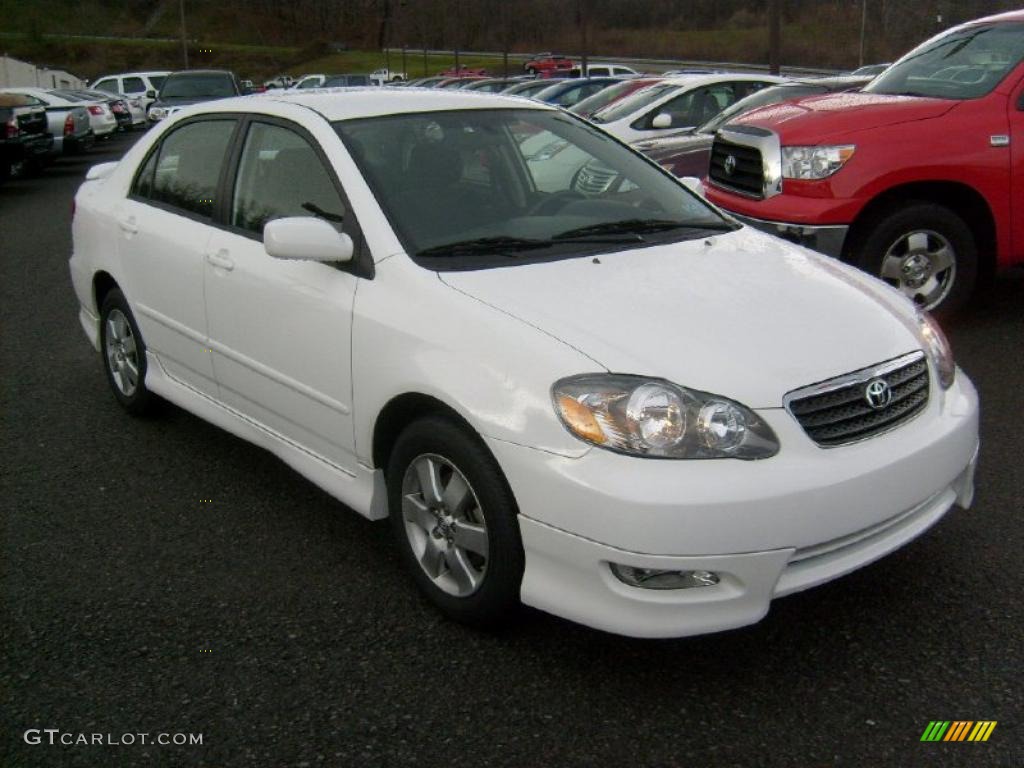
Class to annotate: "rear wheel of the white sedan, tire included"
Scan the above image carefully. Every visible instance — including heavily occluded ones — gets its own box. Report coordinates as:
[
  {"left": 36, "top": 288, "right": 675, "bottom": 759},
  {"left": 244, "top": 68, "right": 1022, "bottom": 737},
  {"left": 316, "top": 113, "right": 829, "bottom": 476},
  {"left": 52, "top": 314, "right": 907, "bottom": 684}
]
[{"left": 99, "top": 288, "right": 156, "bottom": 416}]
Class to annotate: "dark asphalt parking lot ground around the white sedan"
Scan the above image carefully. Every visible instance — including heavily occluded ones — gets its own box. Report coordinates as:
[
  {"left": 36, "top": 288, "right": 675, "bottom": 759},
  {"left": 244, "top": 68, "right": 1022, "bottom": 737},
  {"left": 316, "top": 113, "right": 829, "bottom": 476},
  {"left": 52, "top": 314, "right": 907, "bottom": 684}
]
[{"left": 0, "top": 129, "right": 1024, "bottom": 768}]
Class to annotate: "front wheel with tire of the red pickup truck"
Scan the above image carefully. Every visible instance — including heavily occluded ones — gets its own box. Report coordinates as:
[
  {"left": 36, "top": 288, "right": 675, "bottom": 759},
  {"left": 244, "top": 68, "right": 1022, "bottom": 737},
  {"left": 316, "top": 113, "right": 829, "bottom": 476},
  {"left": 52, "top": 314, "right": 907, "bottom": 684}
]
[{"left": 851, "top": 201, "right": 978, "bottom": 316}]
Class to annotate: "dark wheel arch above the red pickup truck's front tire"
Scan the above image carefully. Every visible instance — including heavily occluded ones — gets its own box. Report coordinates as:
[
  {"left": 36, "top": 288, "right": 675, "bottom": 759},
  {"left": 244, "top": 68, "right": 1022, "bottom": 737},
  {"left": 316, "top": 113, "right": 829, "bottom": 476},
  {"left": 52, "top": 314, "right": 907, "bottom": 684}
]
[{"left": 842, "top": 180, "right": 998, "bottom": 280}]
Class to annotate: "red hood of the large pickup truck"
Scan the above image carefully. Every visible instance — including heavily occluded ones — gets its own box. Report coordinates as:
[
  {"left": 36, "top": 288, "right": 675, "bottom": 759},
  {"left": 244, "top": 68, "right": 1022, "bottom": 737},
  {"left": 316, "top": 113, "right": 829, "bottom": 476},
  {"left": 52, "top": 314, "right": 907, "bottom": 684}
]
[{"left": 731, "top": 92, "right": 957, "bottom": 145}]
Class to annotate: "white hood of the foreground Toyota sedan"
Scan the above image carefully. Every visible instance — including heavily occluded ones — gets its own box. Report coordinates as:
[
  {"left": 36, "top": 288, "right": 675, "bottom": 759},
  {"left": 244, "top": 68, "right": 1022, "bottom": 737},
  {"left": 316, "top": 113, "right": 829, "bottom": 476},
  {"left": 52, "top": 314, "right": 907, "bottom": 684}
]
[{"left": 439, "top": 227, "right": 921, "bottom": 408}]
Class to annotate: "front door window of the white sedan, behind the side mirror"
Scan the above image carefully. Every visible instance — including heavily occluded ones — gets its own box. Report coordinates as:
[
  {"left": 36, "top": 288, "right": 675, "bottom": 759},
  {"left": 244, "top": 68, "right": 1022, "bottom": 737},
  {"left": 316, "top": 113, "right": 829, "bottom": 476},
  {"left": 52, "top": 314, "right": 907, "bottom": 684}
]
[{"left": 231, "top": 123, "right": 345, "bottom": 234}]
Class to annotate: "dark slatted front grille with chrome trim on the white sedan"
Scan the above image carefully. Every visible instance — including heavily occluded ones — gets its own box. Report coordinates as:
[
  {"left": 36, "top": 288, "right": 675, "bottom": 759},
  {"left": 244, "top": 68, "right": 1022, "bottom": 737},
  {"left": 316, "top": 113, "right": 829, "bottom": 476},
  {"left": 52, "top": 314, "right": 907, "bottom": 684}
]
[{"left": 785, "top": 352, "right": 929, "bottom": 447}]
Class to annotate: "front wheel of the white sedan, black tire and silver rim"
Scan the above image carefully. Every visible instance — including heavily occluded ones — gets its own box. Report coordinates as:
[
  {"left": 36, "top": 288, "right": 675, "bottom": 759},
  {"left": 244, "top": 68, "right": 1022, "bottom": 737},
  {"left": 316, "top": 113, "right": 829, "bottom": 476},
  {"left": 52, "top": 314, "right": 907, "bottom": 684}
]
[{"left": 387, "top": 416, "right": 523, "bottom": 627}]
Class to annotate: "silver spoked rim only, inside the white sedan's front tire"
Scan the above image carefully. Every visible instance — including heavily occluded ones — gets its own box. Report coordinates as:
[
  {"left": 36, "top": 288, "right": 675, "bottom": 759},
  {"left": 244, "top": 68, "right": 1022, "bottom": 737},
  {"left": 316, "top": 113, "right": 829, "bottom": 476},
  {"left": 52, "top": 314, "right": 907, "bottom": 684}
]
[{"left": 401, "top": 454, "right": 487, "bottom": 597}]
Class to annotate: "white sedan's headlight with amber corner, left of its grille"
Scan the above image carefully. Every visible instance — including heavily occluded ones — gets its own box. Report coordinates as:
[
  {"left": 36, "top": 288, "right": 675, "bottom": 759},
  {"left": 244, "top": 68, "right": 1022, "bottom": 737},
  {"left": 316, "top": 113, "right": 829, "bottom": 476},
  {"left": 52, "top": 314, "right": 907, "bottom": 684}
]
[{"left": 551, "top": 374, "right": 778, "bottom": 459}]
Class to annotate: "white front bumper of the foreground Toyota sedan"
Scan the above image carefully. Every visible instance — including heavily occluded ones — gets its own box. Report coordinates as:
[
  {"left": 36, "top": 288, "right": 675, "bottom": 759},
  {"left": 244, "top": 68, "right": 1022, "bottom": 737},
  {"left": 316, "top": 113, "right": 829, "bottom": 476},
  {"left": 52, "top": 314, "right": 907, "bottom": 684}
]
[{"left": 488, "top": 374, "right": 978, "bottom": 637}]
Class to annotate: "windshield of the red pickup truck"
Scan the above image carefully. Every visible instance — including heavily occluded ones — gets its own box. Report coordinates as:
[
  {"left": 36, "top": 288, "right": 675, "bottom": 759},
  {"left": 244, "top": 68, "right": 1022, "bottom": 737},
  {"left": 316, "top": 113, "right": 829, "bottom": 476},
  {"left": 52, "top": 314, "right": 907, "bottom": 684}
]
[{"left": 864, "top": 22, "right": 1024, "bottom": 99}]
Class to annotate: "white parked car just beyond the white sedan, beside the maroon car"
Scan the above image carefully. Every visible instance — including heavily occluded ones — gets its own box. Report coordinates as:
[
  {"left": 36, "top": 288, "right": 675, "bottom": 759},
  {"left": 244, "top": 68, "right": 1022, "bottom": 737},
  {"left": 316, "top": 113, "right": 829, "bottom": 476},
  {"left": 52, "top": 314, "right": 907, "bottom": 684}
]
[{"left": 590, "top": 74, "right": 785, "bottom": 143}]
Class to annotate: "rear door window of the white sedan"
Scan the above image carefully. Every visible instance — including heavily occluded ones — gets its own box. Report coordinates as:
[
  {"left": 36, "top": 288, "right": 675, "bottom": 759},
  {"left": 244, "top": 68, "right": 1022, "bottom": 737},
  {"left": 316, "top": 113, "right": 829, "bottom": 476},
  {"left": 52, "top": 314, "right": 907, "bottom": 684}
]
[{"left": 150, "top": 120, "right": 236, "bottom": 218}]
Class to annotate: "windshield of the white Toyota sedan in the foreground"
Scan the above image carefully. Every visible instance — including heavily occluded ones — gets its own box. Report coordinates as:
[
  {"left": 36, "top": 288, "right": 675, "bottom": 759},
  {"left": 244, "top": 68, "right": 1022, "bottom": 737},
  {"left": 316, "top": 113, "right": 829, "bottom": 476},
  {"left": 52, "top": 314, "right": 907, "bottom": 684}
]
[{"left": 335, "top": 109, "right": 734, "bottom": 269}]
